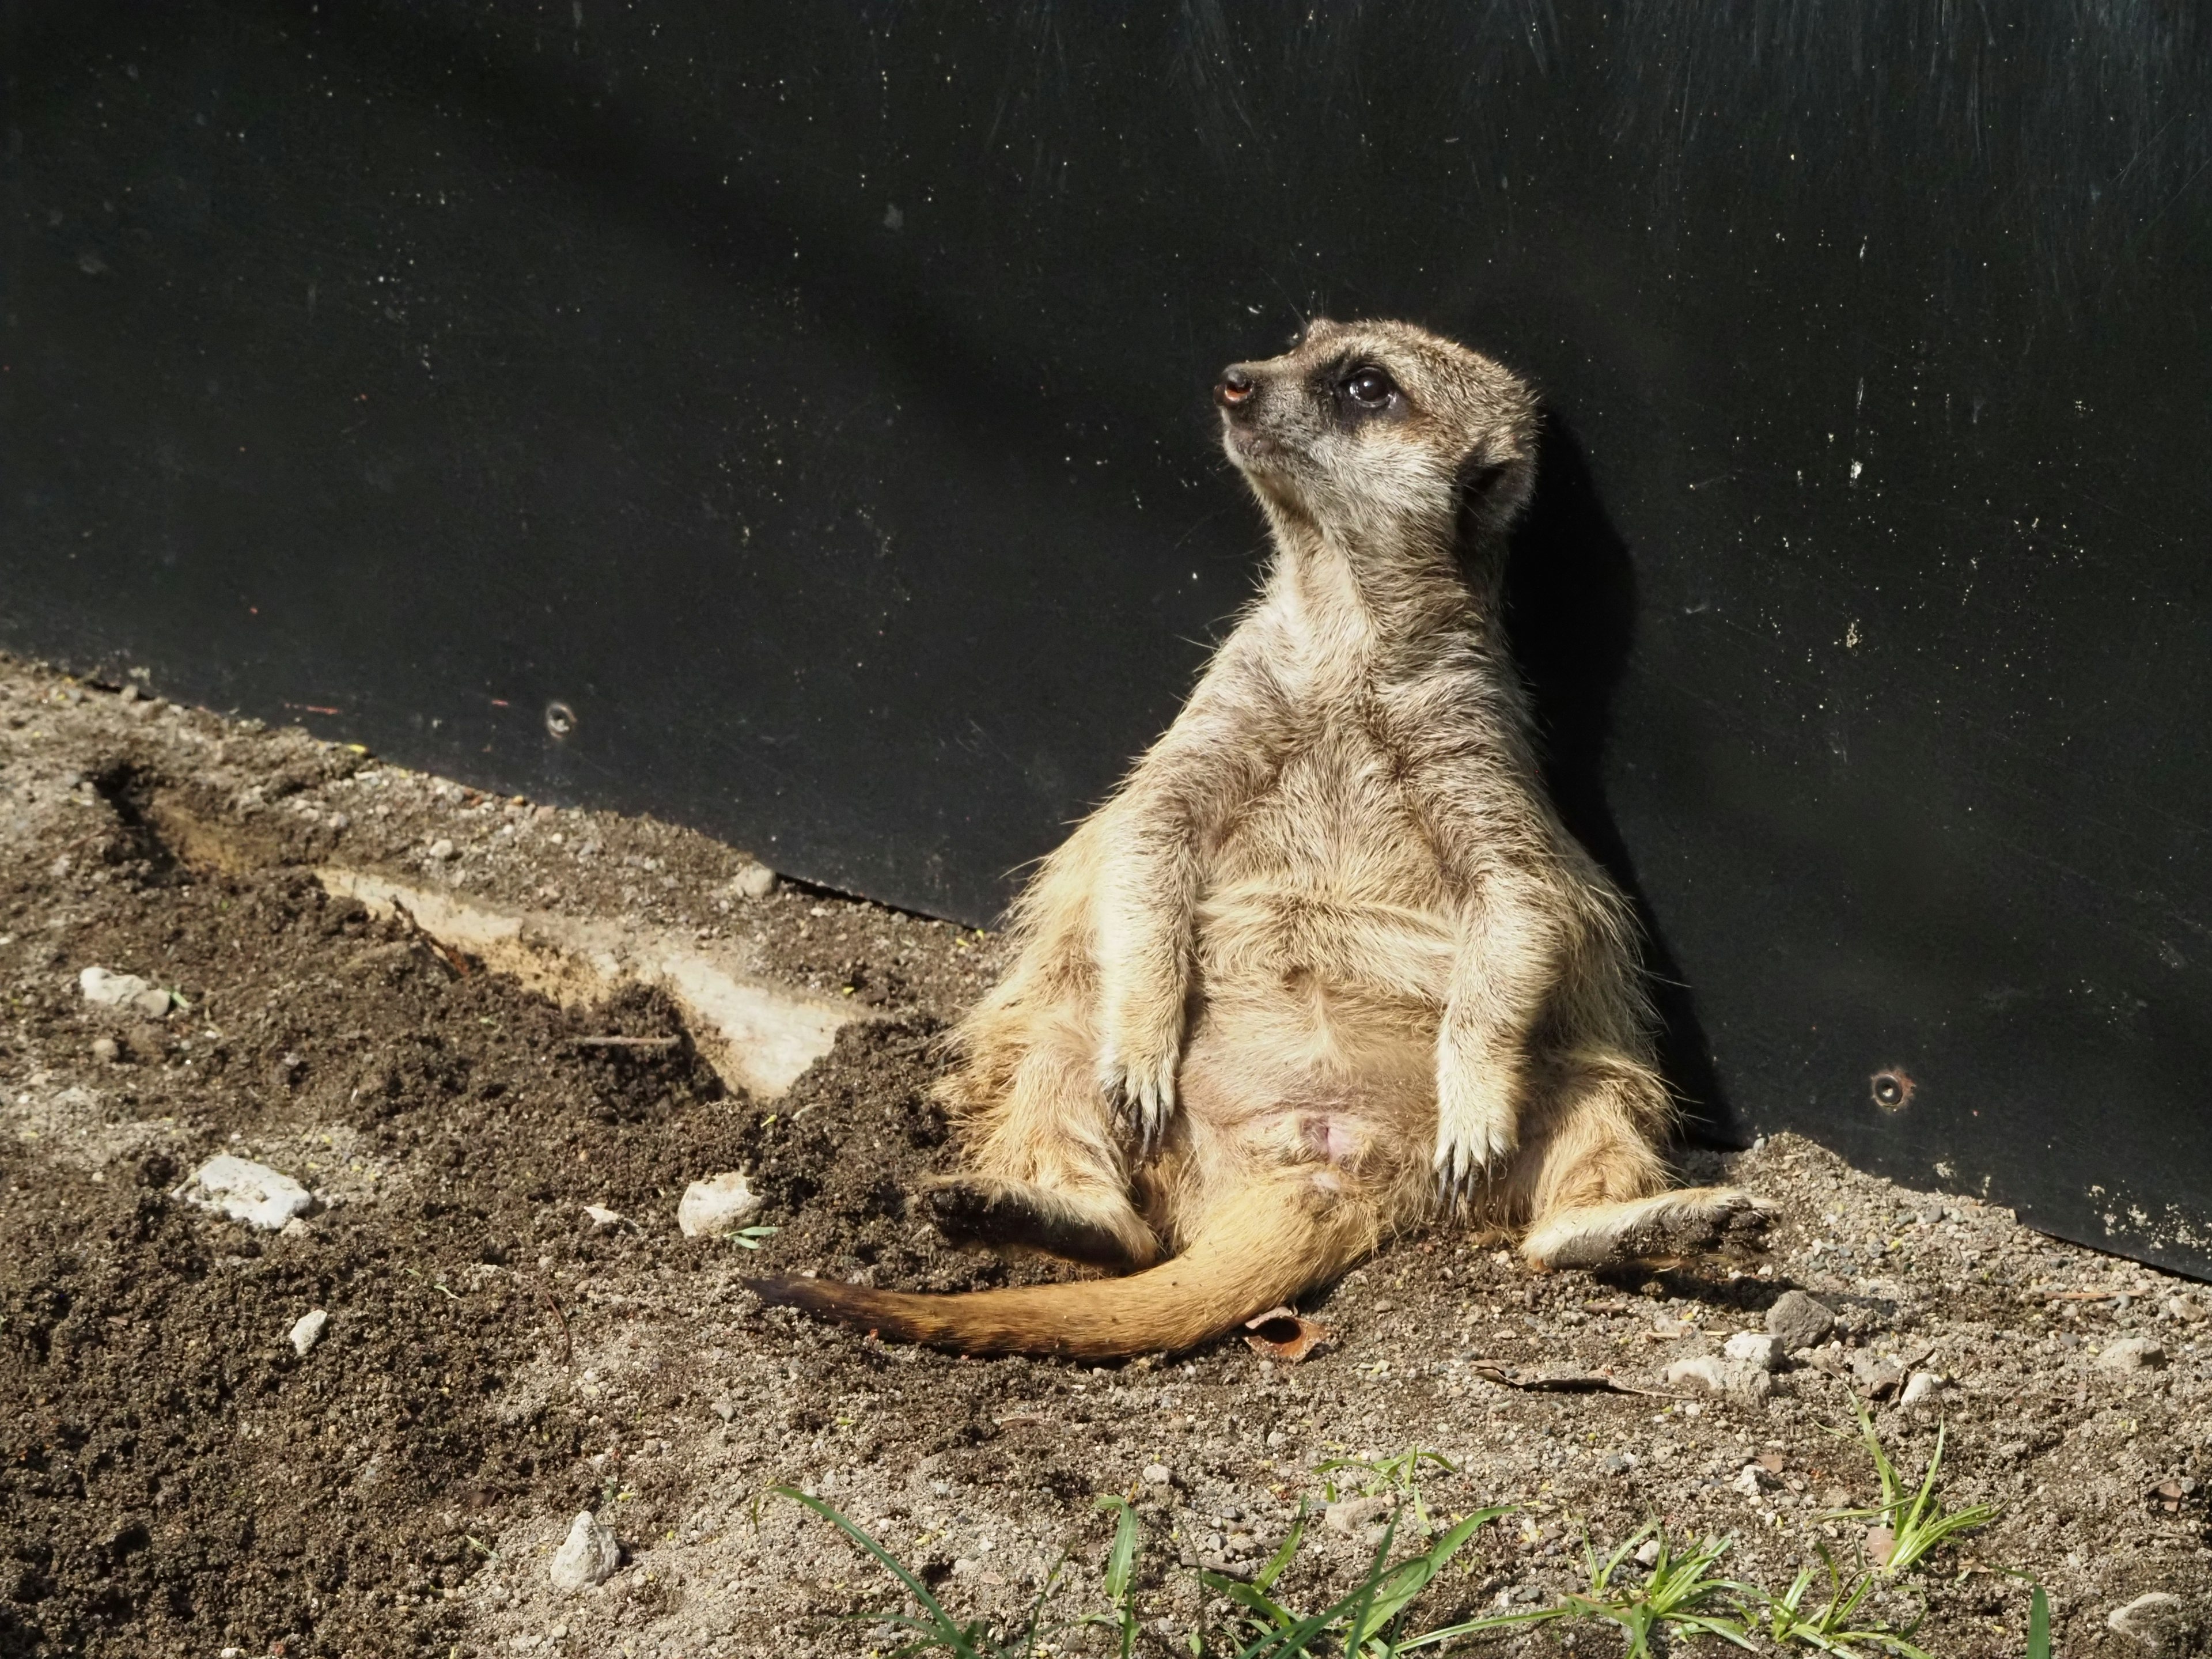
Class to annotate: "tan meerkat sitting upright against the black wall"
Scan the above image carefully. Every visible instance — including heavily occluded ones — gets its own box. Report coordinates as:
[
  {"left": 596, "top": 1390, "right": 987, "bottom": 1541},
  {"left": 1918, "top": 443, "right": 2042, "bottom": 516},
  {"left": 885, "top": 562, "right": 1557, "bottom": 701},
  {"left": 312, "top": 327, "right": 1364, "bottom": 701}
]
[{"left": 754, "top": 321, "right": 1765, "bottom": 1358}]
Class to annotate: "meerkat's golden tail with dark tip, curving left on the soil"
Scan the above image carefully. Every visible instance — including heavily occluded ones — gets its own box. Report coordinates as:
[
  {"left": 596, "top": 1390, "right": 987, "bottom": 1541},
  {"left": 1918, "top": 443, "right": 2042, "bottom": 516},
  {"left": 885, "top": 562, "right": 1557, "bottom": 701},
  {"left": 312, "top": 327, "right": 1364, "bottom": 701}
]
[{"left": 745, "top": 1181, "right": 1376, "bottom": 1361}]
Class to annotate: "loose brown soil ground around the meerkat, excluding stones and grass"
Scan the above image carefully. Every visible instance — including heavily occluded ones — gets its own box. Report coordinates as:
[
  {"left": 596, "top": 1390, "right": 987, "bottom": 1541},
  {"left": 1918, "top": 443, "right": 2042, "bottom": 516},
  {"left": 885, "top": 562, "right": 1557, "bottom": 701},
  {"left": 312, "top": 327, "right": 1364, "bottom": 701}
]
[{"left": 0, "top": 659, "right": 2212, "bottom": 1659}]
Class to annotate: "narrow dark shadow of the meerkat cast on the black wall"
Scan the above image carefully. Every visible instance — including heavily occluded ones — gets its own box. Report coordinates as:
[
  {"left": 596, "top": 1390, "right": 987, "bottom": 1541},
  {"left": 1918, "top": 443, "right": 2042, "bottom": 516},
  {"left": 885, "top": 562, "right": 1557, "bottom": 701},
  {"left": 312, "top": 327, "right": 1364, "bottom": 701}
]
[{"left": 1506, "top": 411, "right": 1748, "bottom": 1146}]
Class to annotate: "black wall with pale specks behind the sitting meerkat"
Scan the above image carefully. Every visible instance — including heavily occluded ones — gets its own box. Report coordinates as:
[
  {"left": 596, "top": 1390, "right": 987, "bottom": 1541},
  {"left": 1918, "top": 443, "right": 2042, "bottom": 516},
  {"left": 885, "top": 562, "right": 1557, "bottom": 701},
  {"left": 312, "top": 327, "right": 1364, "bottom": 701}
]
[{"left": 0, "top": 0, "right": 2212, "bottom": 1270}]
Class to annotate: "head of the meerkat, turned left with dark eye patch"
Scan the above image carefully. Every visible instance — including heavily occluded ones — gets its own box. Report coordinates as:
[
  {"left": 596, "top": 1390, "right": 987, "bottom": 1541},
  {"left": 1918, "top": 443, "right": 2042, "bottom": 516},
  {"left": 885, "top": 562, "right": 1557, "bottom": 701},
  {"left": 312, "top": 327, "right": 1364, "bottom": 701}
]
[{"left": 1214, "top": 321, "right": 1537, "bottom": 555}]
